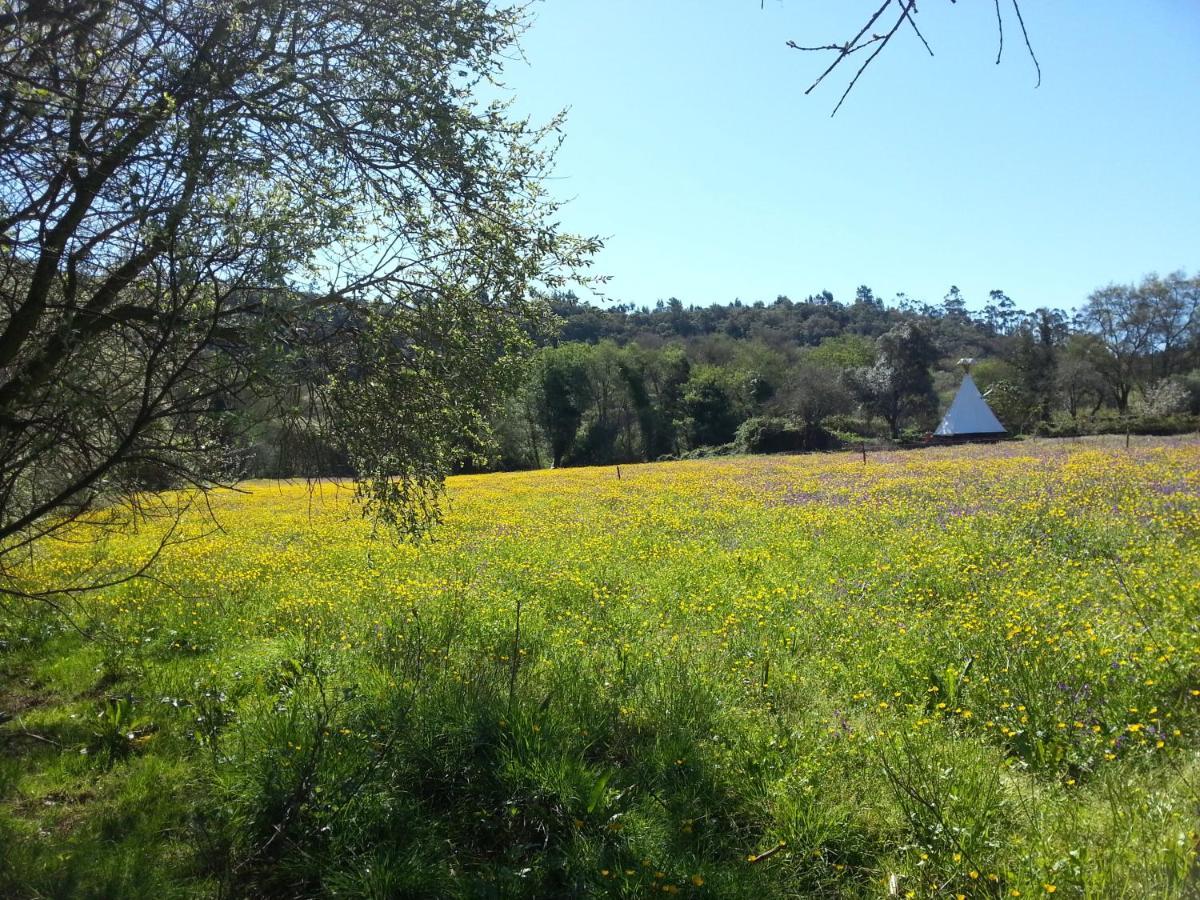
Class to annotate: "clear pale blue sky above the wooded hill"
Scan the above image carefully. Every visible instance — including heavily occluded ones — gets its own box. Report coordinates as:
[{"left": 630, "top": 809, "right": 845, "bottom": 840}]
[{"left": 506, "top": 0, "right": 1200, "bottom": 308}]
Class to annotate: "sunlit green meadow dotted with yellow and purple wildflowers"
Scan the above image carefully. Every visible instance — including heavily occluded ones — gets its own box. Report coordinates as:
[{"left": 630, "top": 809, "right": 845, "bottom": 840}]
[{"left": 0, "top": 439, "right": 1200, "bottom": 898}]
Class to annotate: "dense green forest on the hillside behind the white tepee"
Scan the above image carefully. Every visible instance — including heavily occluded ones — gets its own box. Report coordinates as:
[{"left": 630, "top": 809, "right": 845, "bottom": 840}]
[{"left": 246, "top": 272, "right": 1200, "bottom": 475}]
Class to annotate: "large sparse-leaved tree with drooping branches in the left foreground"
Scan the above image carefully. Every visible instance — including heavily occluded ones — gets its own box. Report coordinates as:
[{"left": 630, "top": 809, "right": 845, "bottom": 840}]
[{"left": 0, "top": 0, "right": 595, "bottom": 585}]
